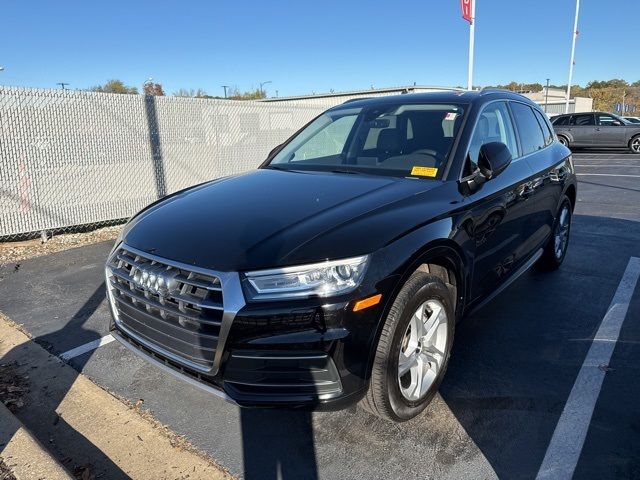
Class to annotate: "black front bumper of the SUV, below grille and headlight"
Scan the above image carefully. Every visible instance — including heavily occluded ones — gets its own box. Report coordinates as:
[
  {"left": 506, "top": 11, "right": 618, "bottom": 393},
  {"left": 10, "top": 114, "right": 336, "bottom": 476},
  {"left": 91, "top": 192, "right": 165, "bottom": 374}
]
[{"left": 111, "top": 302, "right": 378, "bottom": 410}]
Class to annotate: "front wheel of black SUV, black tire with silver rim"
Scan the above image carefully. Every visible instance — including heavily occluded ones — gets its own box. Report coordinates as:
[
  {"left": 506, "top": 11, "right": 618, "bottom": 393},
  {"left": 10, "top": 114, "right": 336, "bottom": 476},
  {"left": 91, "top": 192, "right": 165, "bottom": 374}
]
[{"left": 361, "top": 271, "right": 455, "bottom": 422}]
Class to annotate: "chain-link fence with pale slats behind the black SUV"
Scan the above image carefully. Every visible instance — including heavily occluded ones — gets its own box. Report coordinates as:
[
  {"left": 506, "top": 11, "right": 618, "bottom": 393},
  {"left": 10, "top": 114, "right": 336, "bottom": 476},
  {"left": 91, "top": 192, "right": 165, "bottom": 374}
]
[{"left": 0, "top": 87, "right": 344, "bottom": 240}]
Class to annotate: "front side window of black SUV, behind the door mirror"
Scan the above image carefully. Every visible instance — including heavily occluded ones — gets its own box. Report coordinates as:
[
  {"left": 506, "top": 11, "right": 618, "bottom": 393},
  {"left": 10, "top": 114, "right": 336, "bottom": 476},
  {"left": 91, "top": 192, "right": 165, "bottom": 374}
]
[{"left": 465, "top": 102, "right": 518, "bottom": 175}]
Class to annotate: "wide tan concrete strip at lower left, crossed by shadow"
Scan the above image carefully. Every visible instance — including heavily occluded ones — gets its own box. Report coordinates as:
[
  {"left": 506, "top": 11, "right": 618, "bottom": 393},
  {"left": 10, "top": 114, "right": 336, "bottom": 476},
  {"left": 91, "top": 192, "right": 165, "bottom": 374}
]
[{"left": 0, "top": 315, "right": 231, "bottom": 480}]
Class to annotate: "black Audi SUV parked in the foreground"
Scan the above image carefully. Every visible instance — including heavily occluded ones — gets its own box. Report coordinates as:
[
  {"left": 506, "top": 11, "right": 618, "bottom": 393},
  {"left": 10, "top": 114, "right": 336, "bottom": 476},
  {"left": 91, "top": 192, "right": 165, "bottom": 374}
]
[{"left": 106, "top": 90, "right": 576, "bottom": 421}]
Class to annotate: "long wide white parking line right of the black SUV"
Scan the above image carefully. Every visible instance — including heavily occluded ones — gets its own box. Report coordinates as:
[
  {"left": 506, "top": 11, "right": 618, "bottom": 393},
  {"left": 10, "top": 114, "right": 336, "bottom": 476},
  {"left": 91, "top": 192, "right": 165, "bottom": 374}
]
[{"left": 536, "top": 257, "right": 640, "bottom": 480}]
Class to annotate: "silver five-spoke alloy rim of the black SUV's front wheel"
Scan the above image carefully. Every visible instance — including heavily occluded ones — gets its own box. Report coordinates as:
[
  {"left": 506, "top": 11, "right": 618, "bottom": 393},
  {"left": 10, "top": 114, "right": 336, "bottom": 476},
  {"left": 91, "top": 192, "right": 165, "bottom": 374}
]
[{"left": 398, "top": 299, "right": 448, "bottom": 402}]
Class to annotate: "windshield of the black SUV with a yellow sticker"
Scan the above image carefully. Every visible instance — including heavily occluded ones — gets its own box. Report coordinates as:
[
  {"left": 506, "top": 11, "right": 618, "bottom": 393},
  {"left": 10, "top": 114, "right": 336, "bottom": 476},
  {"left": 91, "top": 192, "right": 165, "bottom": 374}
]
[{"left": 268, "top": 103, "right": 463, "bottom": 178}]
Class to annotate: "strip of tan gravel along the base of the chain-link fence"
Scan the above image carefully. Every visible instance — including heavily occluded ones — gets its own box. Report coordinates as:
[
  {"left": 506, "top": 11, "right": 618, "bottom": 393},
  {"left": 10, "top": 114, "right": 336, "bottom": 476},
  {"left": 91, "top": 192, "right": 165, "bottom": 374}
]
[{"left": 0, "top": 225, "right": 123, "bottom": 265}]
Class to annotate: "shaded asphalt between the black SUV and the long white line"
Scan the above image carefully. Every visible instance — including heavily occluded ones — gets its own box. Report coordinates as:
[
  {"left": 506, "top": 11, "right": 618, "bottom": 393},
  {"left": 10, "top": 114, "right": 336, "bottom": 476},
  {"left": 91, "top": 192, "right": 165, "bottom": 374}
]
[{"left": 440, "top": 215, "right": 640, "bottom": 479}]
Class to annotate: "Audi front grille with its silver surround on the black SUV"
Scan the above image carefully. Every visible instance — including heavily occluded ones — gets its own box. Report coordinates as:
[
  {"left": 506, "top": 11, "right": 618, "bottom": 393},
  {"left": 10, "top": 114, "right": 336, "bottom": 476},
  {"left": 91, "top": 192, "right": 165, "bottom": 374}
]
[{"left": 105, "top": 243, "right": 245, "bottom": 375}]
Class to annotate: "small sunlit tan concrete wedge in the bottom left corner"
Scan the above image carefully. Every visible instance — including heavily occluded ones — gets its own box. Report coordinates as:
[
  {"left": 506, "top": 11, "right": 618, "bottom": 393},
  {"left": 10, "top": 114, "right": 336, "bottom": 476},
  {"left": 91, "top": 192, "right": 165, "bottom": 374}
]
[{"left": 0, "top": 402, "right": 73, "bottom": 480}]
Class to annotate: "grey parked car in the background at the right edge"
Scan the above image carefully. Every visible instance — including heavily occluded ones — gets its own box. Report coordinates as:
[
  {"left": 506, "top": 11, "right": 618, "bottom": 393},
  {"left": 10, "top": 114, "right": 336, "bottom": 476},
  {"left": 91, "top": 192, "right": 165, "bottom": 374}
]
[{"left": 551, "top": 112, "right": 640, "bottom": 153}]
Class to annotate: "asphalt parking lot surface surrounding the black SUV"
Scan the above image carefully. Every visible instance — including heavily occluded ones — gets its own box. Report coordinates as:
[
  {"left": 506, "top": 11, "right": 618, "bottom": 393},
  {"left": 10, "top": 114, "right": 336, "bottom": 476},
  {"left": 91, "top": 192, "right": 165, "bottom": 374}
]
[{"left": 0, "top": 151, "right": 640, "bottom": 479}]
